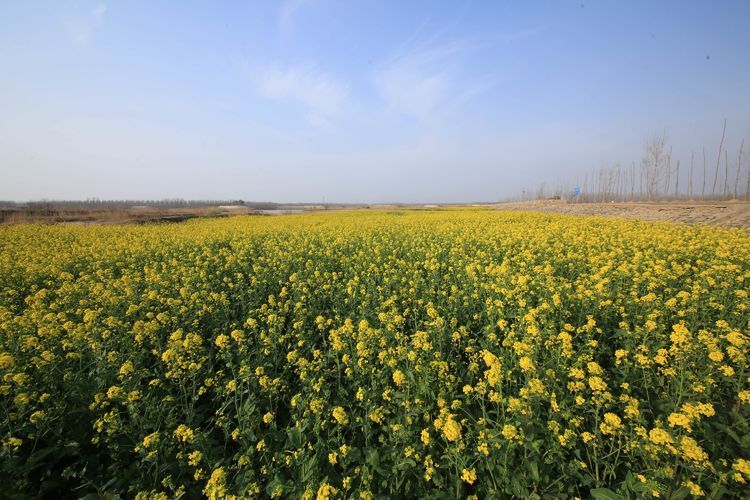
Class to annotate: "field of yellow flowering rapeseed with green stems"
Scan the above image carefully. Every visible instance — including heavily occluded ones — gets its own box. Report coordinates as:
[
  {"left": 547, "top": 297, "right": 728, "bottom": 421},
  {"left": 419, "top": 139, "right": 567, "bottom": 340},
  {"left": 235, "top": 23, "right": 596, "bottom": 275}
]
[{"left": 0, "top": 209, "right": 750, "bottom": 499}]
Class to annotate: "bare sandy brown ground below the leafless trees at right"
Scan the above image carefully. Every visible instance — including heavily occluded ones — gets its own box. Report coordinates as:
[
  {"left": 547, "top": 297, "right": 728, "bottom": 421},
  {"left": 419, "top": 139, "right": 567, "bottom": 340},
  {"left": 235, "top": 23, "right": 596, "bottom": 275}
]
[{"left": 491, "top": 200, "right": 750, "bottom": 229}]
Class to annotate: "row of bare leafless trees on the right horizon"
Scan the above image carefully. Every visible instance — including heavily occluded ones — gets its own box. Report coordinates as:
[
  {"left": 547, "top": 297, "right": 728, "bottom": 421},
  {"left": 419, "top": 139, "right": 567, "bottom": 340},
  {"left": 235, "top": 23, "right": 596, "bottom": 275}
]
[{"left": 514, "top": 120, "right": 750, "bottom": 203}]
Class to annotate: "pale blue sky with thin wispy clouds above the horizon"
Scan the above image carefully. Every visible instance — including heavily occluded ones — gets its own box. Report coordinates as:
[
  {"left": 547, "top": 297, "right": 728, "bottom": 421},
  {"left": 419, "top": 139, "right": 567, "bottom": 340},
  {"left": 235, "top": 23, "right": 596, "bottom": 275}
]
[{"left": 0, "top": 0, "right": 750, "bottom": 203}]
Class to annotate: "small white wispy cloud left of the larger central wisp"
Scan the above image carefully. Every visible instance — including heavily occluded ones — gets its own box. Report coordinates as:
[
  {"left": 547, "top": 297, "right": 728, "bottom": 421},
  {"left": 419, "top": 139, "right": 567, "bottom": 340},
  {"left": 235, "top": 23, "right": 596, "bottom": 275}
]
[{"left": 251, "top": 64, "right": 350, "bottom": 127}]
